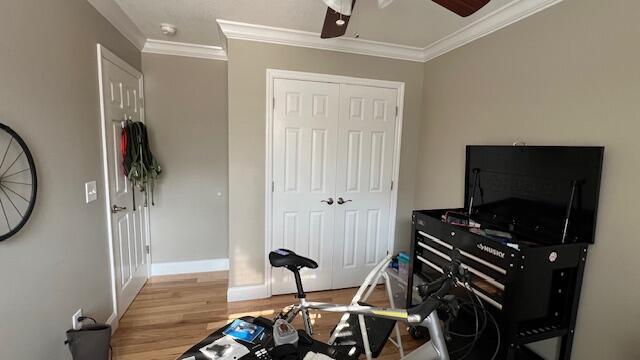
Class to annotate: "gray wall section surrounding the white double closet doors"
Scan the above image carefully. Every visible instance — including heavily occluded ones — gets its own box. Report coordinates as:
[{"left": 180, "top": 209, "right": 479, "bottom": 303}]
[{"left": 228, "top": 40, "right": 424, "bottom": 286}]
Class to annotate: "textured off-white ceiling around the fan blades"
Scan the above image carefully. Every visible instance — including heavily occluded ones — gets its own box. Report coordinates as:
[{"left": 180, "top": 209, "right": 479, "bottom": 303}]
[{"left": 113, "top": 0, "right": 513, "bottom": 47}]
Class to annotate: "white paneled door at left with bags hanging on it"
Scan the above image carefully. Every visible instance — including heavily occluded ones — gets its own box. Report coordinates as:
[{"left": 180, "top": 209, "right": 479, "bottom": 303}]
[{"left": 101, "top": 49, "right": 149, "bottom": 319}]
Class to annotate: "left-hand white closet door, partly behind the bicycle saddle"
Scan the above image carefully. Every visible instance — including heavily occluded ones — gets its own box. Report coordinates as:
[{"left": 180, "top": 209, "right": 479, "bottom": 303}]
[{"left": 270, "top": 79, "right": 340, "bottom": 295}]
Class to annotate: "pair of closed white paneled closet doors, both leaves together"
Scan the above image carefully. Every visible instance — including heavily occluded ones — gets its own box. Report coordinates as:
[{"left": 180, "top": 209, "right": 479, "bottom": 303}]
[{"left": 271, "top": 79, "right": 398, "bottom": 295}]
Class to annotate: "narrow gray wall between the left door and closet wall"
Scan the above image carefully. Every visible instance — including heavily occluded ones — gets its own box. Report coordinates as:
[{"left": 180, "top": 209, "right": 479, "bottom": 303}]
[{"left": 142, "top": 53, "right": 228, "bottom": 264}]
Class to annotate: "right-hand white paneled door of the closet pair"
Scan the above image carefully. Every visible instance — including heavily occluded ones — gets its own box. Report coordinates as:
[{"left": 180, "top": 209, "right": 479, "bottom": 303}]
[{"left": 333, "top": 85, "right": 398, "bottom": 289}]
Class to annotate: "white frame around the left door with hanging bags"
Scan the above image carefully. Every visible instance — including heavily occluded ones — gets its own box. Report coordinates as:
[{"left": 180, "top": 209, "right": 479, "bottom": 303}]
[{"left": 97, "top": 44, "right": 151, "bottom": 332}]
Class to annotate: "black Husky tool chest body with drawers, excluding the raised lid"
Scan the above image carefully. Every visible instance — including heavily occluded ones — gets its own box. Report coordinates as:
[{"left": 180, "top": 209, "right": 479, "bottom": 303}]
[{"left": 407, "top": 209, "right": 587, "bottom": 359}]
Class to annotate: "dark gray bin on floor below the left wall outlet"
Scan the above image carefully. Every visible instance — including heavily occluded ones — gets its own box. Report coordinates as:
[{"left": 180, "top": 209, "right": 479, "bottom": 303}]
[{"left": 65, "top": 324, "right": 111, "bottom": 360}]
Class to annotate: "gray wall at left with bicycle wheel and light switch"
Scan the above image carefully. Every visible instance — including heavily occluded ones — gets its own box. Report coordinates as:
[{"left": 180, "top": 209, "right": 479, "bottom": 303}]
[{"left": 0, "top": 0, "right": 140, "bottom": 359}]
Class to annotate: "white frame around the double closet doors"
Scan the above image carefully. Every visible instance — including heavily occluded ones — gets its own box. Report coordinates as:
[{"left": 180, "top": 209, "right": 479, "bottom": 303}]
[{"left": 264, "top": 69, "right": 405, "bottom": 297}]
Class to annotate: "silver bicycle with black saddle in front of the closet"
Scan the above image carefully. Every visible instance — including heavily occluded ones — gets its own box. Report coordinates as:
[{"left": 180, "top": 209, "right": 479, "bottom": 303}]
[{"left": 269, "top": 249, "right": 499, "bottom": 360}]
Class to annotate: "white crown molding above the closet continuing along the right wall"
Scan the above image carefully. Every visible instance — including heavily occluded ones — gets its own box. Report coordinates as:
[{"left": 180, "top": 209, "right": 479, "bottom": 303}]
[{"left": 217, "top": 0, "right": 562, "bottom": 62}]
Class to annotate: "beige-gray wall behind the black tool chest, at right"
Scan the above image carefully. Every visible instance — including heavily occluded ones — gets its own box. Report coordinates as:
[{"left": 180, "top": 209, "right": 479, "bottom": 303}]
[{"left": 416, "top": 0, "right": 640, "bottom": 360}]
